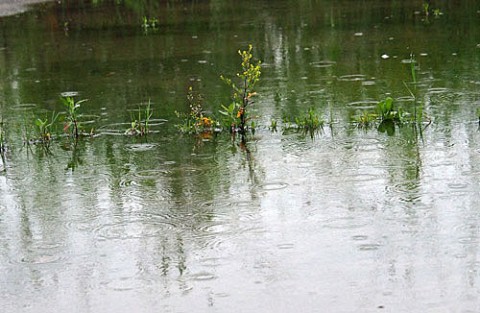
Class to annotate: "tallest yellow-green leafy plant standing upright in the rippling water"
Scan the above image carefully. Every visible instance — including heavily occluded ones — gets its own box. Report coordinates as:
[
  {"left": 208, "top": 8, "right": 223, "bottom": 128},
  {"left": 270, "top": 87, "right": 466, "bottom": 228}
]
[{"left": 219, "top": 45, "right": 262, "bottom": 134}]
